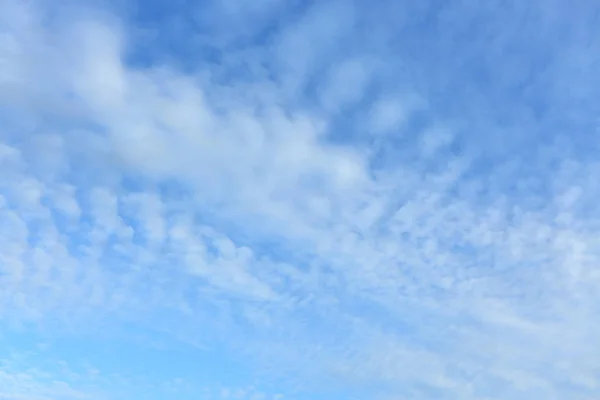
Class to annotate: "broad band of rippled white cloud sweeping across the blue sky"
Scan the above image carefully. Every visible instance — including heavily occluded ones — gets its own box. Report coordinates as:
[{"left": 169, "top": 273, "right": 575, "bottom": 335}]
[{"left": 0, "top": 1, "right": 600, "bottom": 399}]
